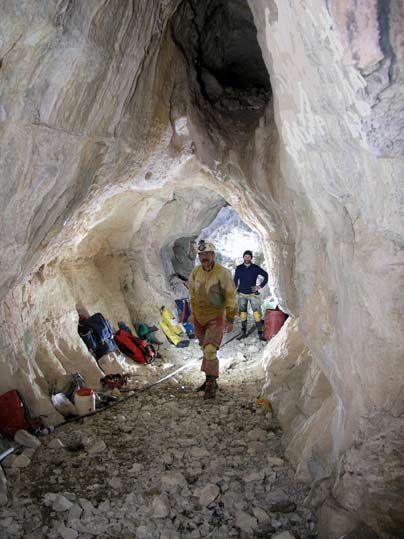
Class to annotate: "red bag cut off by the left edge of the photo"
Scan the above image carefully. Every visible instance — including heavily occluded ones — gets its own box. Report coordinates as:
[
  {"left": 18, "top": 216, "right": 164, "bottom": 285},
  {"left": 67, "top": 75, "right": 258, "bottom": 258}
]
[{"left": 0, "top": 389, "right": 42, "bottom": 438}]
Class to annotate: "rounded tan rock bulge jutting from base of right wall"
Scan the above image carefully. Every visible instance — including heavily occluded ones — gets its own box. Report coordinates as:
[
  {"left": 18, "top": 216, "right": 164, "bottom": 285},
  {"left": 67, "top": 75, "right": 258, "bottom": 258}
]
[{"left": 263, "top": 319, "right": 338, "bottom": 481}]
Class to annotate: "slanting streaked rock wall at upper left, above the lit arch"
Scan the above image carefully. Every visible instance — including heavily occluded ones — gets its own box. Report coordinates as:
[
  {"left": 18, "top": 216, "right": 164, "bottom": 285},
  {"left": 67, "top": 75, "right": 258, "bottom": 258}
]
[{"left": 0, "top": 0, "right": 180, "bottom": 296}]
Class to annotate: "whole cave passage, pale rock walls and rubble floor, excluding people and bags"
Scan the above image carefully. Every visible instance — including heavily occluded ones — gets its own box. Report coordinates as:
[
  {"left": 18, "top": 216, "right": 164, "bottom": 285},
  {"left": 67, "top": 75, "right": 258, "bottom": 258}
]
[{"left": 0, "top": 0, "right": 404, "bottom": 539}]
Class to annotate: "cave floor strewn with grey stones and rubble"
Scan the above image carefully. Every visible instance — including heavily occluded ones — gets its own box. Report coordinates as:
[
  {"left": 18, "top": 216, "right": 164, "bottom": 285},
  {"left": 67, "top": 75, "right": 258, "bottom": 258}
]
[{"left": 0, "top": 324, "right": 316, "bottom": 539}]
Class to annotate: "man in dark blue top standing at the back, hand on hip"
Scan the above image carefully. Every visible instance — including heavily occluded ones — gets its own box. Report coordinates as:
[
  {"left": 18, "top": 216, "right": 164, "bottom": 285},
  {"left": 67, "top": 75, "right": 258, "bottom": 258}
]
[{"left": 234, "top": 251, "right": 268, "bottom": 341}]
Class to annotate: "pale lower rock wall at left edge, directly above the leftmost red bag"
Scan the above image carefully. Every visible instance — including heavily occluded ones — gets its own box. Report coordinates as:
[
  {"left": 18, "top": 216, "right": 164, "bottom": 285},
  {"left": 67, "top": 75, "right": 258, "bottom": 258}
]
[{"left": 0, "top": 267, "right": 103, "bottom": 424}]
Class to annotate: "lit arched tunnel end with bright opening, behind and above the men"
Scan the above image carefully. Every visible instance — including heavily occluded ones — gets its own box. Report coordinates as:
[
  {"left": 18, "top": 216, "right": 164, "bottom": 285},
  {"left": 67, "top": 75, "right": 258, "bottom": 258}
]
[{"left": 60, "top": 186, "right": 273, "bottom": 336}]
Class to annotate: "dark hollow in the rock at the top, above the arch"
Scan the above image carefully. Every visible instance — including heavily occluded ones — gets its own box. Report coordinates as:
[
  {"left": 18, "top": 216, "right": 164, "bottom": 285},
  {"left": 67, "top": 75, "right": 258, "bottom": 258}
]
[{"left": 172, "top": 0, "right": 272, "bottom": 115}]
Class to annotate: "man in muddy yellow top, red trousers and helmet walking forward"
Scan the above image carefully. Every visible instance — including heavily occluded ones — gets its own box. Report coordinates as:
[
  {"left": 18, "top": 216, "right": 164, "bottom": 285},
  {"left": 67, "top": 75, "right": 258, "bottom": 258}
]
[{"left": 188, "top": 240, "right": 237, "bottom": 399}]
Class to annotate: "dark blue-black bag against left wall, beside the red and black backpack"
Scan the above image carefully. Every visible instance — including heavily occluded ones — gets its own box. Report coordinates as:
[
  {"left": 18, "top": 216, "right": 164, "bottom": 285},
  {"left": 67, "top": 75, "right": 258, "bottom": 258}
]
[{"left": 78, "top": 313, "right": 117, "bottom": 359}]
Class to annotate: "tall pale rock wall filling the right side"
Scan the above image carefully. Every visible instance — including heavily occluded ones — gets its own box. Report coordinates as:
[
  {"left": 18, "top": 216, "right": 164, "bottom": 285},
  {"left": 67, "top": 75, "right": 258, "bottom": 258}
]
[{"left": 246, "top": 0, "right": 404, "bottom": 537}]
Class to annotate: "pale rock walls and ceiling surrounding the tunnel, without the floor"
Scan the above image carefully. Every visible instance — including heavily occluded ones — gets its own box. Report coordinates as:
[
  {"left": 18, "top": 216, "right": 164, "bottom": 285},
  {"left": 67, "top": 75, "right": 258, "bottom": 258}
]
[{"left": 0, "top": 0, "right": 404, "bottom": 538}]
